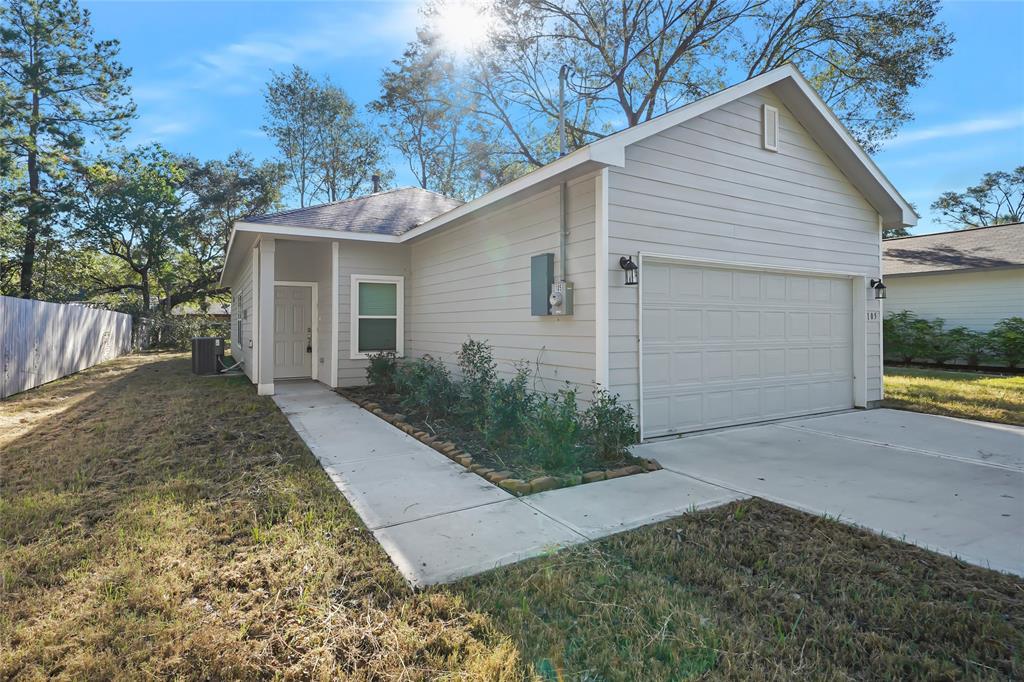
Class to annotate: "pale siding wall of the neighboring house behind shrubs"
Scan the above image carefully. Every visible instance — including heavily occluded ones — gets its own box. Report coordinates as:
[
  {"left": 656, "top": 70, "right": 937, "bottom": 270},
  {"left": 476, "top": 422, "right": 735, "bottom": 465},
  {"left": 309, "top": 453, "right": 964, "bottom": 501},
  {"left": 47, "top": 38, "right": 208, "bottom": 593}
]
[{"left": 885, "top": 268, "right": 1024, "bottom": 332}]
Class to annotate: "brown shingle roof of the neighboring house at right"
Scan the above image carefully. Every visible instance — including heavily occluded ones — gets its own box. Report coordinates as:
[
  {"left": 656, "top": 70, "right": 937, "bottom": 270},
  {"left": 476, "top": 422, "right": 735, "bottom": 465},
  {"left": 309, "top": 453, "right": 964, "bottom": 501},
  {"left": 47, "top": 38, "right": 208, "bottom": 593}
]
[{"left": 882, "top": 222, "right": 1024, "bottom": 275}]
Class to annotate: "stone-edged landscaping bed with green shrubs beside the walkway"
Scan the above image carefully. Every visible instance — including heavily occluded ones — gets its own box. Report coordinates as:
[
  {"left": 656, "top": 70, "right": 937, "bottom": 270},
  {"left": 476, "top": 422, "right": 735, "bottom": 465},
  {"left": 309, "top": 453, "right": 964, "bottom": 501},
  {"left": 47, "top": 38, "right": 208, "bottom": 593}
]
[{"left": 338, "top": 340, "right": 660, "bottom": 495}]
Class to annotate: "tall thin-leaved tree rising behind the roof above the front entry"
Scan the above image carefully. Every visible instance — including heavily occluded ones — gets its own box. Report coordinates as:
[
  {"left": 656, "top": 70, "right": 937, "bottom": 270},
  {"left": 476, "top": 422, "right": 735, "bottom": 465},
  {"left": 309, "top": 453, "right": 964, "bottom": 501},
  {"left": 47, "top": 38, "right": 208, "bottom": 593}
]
[{"left": 263, "top": 67, "right": 391, "bottom": 206}]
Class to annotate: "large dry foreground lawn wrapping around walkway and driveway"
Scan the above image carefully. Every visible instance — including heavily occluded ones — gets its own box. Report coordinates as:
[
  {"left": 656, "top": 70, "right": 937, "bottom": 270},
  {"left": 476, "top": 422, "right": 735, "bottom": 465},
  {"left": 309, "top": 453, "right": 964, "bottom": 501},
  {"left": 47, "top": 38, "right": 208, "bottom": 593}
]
[{"left": 0, "top": 355, "right": 1024, "bottom": 681}]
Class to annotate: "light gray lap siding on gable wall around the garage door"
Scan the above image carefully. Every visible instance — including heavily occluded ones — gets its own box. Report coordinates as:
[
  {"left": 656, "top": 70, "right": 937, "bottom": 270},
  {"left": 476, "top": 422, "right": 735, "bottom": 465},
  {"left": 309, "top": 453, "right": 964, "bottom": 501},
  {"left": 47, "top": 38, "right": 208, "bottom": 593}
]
[{"left": 608, "top": 89, "right": 882, "bottom": 406}]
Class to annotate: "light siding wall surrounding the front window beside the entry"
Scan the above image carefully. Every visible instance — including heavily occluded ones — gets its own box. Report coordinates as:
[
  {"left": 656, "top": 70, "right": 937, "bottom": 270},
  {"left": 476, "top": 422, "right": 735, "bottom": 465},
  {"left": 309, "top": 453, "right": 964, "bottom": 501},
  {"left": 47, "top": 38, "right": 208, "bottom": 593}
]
[{"left": 337, "top": 242, "right": 414, "bottom": 386}]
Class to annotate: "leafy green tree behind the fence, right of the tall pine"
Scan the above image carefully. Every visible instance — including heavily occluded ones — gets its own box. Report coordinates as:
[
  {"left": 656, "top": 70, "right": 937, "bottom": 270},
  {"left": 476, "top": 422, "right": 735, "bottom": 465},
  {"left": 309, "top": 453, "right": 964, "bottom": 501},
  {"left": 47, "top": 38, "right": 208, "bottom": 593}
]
[{"left": 74, "top": 145, "right": 185, "bottom": 313}]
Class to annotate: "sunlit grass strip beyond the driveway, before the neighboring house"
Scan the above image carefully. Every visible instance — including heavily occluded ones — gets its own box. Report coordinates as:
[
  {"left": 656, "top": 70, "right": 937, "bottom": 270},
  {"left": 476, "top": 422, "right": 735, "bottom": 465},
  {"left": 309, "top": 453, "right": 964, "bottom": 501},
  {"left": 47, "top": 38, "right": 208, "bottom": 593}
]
[{"left": 885, "top": 367, "right": 1024, "bottom": 426}]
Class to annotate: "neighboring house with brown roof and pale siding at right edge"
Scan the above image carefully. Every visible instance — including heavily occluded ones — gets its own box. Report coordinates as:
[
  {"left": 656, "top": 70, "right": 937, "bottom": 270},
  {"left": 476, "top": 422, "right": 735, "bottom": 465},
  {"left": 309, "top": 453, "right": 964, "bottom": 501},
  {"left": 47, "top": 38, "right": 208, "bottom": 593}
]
[{"left": 882, "top": 222, "right": 1024, "bottom": 332}]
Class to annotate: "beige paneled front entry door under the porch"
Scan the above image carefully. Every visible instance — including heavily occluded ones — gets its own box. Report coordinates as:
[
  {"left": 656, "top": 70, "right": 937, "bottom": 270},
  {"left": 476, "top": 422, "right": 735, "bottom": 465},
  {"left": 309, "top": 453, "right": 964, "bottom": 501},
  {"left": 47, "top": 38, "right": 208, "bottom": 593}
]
[{"left": 273, "top": 286, "right": 313, "bottom": 379}]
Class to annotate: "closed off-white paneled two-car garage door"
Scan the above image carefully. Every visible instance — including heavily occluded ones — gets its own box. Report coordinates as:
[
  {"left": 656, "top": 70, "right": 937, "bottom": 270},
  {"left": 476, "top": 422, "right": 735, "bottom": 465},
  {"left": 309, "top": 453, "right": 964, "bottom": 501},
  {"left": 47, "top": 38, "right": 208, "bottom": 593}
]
[{"left": 640, "top": 260, "right": 853, "bottom": 438}]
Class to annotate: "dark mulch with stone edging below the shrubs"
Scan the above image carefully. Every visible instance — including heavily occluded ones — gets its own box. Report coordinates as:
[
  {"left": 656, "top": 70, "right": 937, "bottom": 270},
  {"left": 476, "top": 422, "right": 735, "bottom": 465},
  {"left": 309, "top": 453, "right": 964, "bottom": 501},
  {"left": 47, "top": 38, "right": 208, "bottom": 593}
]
[{"left": 338, "top": 386, "right": 662, "bottom": 495}]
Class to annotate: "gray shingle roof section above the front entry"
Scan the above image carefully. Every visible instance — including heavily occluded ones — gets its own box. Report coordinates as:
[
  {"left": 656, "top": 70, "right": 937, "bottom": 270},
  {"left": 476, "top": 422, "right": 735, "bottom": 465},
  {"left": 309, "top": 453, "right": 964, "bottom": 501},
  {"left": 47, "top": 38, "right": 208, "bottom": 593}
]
[{"left": 247, "top": 187, "right": 462, "bottom": 235}]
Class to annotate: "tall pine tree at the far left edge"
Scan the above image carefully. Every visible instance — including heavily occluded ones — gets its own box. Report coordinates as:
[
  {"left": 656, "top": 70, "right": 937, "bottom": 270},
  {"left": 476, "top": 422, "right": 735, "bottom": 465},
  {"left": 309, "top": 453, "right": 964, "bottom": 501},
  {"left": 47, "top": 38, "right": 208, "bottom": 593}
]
[{"left": 0, "top": 0, "right": 134, "bottom": 298}]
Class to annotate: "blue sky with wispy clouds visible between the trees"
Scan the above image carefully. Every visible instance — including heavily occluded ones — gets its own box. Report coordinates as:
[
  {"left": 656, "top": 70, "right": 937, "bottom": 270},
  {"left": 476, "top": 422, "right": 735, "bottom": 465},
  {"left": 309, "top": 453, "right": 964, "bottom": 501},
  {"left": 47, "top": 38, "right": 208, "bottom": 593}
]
[{"left": 83, "top": 0, "right": 1024, "bottom": 233}]
